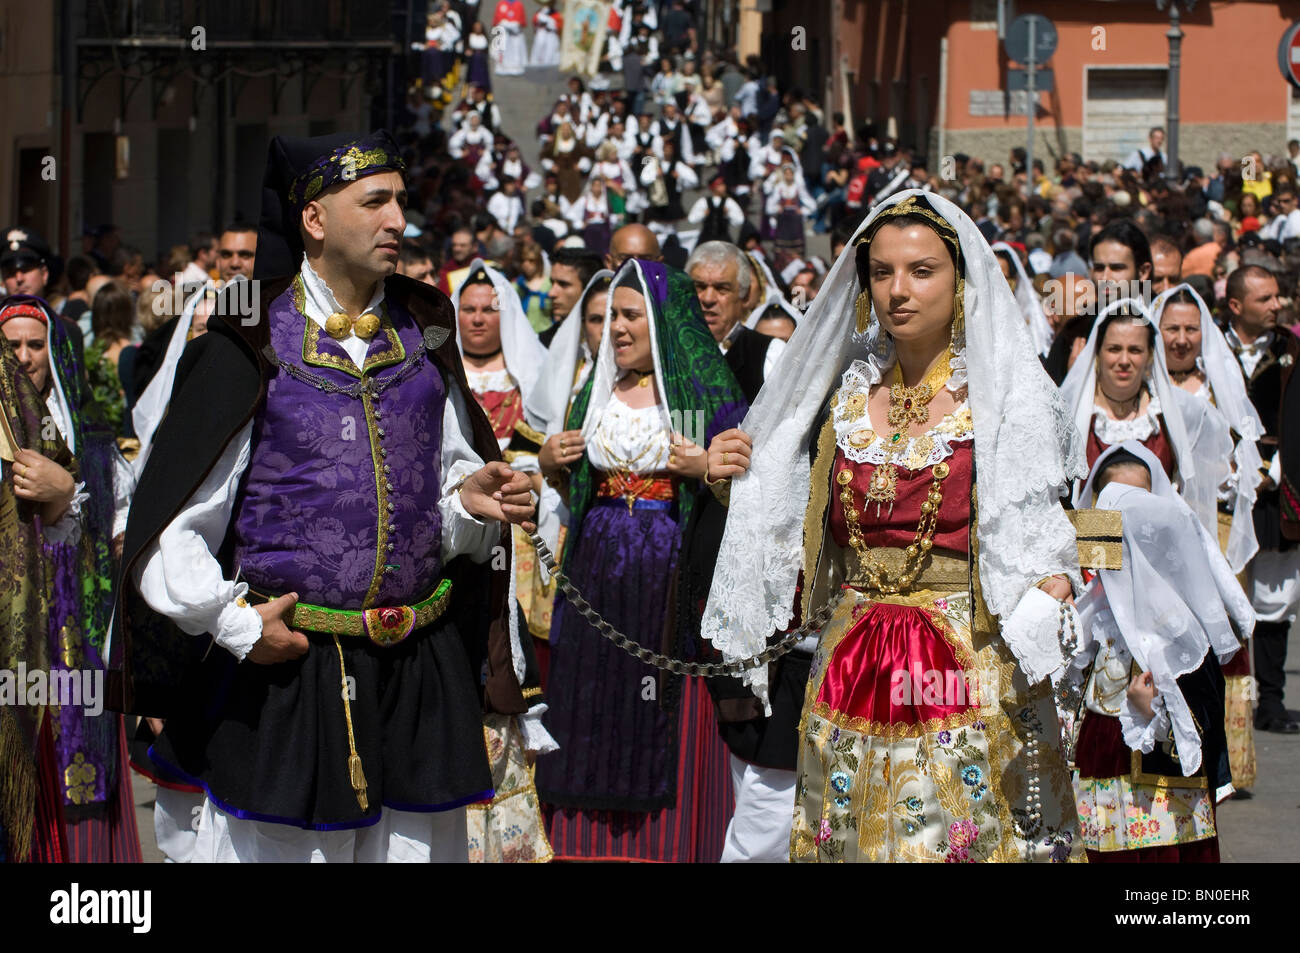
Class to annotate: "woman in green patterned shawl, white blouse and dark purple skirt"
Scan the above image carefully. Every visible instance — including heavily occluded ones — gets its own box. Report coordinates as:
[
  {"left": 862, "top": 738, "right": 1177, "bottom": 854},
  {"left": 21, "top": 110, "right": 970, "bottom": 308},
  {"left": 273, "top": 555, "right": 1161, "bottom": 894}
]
[{"left": 537, "top": 259, "right": 746, "bottom": 862}]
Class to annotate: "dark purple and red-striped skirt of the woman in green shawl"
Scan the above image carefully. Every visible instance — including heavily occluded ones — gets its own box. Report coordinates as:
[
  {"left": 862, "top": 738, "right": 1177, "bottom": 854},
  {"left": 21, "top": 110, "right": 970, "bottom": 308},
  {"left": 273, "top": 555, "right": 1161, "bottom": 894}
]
[{"left": 537, "top": 499, "right": 735, "bottom": 862}]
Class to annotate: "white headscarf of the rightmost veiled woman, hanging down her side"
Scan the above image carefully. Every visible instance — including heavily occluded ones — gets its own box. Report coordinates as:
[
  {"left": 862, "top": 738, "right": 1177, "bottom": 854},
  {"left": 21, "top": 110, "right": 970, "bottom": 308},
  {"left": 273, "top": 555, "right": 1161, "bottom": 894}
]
[{"left": 1151, "top": 282, "right": 1264, "bottom": 572}]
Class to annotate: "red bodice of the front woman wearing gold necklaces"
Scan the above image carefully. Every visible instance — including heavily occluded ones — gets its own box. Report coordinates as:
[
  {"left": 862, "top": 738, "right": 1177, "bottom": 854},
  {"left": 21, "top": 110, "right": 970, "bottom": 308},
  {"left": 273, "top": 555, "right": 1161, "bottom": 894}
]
[{"left": 831, "top": 441, "right": 974, "bottom": 554}]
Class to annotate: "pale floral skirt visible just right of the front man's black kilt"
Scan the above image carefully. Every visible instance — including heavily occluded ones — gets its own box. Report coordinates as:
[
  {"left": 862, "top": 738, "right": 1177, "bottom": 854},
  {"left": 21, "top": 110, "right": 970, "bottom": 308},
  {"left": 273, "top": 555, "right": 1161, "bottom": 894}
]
[{"left": 467, "top": 715, "right": 553, "bottom": 863}]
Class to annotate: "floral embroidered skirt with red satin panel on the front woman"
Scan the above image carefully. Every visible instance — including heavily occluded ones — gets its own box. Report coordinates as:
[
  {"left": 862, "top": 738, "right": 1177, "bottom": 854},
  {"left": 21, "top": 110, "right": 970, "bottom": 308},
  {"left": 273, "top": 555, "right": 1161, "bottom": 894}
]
[{"left": 790, "top": 589, "right": 1083, "bottom": 863}]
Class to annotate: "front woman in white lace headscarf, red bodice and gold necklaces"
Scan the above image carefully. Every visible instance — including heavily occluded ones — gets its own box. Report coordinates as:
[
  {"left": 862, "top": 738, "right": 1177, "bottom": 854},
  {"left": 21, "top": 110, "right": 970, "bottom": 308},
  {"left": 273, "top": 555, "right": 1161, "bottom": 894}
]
[{"left": 702, "top": 190, "right": 1084, "bottom": 862}]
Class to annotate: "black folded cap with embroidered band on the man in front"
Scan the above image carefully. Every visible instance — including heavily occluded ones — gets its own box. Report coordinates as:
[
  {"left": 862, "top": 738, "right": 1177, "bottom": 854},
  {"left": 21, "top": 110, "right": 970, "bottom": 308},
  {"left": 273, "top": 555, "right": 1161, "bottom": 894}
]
[{"left": 254, "top": 129, "right": 406, "bottom": 278}]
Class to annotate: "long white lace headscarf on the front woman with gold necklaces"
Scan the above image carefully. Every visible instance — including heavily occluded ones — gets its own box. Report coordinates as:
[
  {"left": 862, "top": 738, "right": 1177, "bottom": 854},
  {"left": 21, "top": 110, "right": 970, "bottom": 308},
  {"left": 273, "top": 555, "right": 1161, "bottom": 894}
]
[{"left": 702, "top": 189, "right": 1087, "bottom": 703}]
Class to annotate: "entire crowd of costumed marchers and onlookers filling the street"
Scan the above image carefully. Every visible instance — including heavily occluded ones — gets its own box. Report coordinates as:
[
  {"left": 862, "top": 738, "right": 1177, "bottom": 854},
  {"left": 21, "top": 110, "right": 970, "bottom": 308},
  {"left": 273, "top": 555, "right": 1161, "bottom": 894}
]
[{"left": 0, "top": 0, "right": 1300, "bottom": 862}]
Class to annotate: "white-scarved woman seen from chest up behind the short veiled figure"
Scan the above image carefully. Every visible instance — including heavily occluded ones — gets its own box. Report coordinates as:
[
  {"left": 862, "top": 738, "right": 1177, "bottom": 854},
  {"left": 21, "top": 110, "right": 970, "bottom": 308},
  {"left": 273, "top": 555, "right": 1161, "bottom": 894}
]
[{"left": 1061, "top": 298, "right": 1232, "bottom": 546}]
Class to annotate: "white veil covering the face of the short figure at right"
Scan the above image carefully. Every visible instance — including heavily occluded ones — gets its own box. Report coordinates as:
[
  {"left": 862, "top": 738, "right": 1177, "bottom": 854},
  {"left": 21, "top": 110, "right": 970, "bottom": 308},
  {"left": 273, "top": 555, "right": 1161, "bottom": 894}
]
[{"left": 1075, "top": 441, "right": 1255, "bottom": 776}]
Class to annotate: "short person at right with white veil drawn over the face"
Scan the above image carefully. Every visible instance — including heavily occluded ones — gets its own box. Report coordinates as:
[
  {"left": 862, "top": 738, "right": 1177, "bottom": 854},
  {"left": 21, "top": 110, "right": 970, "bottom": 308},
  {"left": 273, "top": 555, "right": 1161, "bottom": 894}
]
[{"left": 1071, "top": 441, "right": 1255, "bottom": 863}]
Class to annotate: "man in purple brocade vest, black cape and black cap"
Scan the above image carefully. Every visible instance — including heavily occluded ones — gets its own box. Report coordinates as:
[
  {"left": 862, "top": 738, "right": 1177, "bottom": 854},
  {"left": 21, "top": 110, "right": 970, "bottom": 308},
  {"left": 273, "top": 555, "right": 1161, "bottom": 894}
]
[{"left": 111, "top": 131, "right": 533, "bottom": 862}]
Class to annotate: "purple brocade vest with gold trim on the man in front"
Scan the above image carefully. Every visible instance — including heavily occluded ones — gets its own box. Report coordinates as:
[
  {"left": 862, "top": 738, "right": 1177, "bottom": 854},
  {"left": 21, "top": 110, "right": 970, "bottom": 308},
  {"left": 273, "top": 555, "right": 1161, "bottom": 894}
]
[{"left": 234, "top": 280, "right": 447, "bottom": 610}]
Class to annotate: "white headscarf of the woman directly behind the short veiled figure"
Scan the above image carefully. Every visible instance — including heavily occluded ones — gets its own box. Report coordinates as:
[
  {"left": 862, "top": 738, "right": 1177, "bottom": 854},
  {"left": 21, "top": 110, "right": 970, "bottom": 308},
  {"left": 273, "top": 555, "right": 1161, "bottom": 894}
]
[{"left": 1061, "top": 298, "right": 1232, "bottom": 551}]
